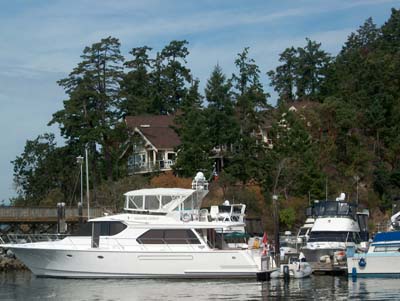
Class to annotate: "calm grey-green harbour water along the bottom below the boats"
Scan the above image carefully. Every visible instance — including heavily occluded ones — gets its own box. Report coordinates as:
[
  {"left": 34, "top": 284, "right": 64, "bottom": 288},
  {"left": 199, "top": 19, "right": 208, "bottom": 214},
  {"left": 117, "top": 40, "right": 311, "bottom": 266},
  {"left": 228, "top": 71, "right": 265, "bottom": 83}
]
[{"left": 0, "top": 272, "right": 400, "bottom": 301}]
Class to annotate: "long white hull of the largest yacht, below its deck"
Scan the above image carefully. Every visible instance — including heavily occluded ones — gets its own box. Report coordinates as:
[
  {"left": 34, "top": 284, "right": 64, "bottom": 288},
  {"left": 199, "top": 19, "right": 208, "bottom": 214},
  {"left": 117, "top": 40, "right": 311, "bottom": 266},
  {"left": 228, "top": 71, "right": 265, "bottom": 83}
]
[{"left": 12, "top": 247, "right": 260, "bottom": 278}]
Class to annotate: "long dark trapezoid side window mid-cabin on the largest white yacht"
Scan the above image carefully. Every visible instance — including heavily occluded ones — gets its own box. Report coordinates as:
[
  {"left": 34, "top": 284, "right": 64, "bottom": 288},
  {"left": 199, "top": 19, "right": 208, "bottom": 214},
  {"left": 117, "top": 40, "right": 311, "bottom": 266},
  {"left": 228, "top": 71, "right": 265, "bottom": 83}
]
[{"left": 136, "top": 229, "right": 200, "bottom": 244}]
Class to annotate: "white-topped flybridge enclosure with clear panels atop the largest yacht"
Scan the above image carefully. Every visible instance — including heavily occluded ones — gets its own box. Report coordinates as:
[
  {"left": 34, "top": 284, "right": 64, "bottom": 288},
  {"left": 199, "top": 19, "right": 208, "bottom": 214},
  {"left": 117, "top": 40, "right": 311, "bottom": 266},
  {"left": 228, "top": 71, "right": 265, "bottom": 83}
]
[{"left": 124, "top": 188, "right": 204, "bottom": 213}]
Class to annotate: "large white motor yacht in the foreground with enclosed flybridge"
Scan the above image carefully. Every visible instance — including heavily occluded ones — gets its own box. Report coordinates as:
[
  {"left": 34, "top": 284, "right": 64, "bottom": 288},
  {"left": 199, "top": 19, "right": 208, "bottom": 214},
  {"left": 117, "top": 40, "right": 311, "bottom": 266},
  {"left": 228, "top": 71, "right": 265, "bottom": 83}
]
[{"left": 1, "top": 173, "right": 262, "bottom": 278}]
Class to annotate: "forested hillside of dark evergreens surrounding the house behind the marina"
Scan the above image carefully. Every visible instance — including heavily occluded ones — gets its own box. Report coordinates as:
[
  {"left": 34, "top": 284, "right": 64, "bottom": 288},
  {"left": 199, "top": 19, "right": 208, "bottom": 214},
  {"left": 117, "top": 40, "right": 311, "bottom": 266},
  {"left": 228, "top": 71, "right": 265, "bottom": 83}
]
[{"left": 12, "top": 9, "right": 400, "bottom": 228}]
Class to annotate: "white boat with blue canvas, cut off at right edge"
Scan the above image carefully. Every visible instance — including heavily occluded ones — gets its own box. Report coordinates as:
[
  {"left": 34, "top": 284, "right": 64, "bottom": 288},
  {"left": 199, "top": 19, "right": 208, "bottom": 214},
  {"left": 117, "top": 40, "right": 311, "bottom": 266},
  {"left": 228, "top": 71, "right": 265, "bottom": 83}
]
[{"left": 347, "top": 231, "right": 400, "bottom": 278}]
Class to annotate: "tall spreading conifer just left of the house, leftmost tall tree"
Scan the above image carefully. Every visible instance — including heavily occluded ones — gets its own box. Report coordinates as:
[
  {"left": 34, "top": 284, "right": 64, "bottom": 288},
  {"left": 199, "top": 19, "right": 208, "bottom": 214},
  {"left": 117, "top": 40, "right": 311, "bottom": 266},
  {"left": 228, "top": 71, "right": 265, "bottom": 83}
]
[{"left": 49, "top": 37, "right": 124, "bottom": 178}]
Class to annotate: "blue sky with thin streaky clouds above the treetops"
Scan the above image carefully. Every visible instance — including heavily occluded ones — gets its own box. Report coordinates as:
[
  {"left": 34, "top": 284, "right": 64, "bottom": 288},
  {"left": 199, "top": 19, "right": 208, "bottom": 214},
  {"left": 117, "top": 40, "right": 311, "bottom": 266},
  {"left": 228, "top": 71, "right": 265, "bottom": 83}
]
[{"left": 0, "top": 0, "right": 400, "bottom": 201}]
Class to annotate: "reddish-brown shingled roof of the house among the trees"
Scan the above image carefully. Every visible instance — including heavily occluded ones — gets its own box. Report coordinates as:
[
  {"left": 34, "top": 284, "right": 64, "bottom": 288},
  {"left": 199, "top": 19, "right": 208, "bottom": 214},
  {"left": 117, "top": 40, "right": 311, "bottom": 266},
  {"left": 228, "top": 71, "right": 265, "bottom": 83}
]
[{"left": 125, "top": 115, "right": 181, "bottom": 149}]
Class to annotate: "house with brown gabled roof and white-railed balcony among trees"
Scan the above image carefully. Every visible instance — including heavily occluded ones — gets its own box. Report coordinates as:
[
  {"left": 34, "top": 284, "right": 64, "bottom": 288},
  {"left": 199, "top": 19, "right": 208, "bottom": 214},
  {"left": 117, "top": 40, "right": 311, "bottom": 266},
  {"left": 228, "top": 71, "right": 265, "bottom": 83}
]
[{"left": 125, "top": 115, "right": 181, "bottom": 174}]
